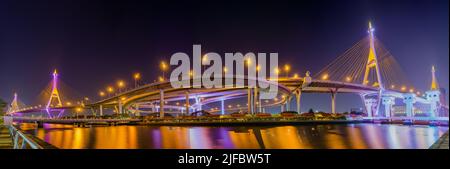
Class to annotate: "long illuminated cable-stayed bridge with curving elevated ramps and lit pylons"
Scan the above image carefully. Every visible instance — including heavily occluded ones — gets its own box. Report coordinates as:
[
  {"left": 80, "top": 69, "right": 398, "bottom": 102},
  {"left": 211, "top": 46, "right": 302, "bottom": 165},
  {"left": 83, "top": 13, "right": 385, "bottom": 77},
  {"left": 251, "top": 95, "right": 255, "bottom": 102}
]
[{"left": 4, "top": 23, "right": 448, "bottom": 121}]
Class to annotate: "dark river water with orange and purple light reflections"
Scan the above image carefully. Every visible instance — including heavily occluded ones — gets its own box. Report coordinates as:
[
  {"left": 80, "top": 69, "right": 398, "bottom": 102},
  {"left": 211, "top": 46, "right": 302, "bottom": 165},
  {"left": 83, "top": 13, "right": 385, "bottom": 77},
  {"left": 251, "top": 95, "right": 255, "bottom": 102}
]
[{"left": 22, "top": 124, "right": 448, "bottom": 149}]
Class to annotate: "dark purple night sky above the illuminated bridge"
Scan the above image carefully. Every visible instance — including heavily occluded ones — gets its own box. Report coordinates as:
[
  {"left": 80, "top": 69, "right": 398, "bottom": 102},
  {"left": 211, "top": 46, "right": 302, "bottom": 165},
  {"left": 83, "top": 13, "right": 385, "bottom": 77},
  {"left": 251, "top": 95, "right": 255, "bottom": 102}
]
[{"left": 0, "top": 0, "right": 449, "bottom": 111}]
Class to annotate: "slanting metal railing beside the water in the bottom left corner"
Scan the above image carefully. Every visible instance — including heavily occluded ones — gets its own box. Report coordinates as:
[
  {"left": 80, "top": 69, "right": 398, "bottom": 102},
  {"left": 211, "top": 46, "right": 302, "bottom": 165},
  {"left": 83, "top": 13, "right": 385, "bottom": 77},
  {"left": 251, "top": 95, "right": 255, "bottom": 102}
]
[{"left": 9, "top": 125, "right": 44, "bottom": 149}]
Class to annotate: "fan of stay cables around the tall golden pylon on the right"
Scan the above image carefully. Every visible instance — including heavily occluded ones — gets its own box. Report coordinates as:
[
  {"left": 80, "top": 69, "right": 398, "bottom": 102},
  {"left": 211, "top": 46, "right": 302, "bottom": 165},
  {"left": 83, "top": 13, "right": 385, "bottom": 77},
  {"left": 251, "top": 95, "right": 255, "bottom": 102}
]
[{"left": 314, "top": 36, "right": 411, "bottom": 88}]
